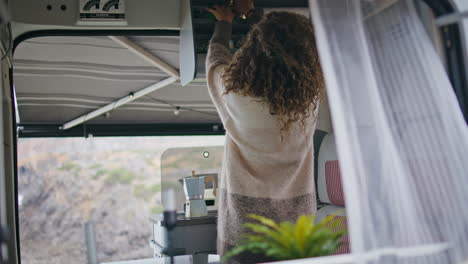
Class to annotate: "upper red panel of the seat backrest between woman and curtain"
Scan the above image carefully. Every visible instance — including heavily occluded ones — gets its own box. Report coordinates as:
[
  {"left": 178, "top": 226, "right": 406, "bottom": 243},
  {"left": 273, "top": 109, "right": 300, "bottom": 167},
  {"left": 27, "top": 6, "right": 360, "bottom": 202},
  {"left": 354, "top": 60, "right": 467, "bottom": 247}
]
[{"left": 325, "top": 160, "right": 345, "bottom": 206}]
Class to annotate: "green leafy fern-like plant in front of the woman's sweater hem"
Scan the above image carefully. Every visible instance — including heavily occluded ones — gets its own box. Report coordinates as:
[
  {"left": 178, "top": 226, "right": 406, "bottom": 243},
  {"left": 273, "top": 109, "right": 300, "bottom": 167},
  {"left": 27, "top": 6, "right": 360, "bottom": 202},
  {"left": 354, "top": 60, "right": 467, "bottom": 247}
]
[{"left": 223, "top": 215, "right": 346, "bottom": 261}]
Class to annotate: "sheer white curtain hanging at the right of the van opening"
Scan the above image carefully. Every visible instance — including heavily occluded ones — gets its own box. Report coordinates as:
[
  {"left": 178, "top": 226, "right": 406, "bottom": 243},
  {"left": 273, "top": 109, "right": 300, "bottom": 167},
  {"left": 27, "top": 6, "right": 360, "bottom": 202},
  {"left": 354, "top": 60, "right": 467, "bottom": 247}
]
[{"left": 296, "top": 0, "right": 468, "bottom": 264}]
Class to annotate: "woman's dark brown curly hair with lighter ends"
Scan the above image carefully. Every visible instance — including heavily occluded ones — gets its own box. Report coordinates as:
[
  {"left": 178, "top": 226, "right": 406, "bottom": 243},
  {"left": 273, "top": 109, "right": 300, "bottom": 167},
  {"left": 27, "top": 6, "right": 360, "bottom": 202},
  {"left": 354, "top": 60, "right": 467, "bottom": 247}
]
[{"left": 223, "top": 12, "right": 324, "bottom": 133}]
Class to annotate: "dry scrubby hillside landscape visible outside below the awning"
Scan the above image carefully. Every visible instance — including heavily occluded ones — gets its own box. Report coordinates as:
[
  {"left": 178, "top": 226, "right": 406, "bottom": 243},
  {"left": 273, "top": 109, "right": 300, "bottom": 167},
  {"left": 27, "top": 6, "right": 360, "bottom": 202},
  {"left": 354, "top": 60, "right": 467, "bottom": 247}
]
[{"left": 18, "top": 136, "right": 224, "bottom": 264}]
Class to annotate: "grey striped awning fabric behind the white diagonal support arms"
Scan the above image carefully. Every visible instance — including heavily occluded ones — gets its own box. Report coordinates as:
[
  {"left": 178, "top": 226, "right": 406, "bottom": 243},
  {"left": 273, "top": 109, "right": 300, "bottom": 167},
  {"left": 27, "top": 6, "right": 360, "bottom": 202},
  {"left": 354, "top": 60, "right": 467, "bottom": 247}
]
[{"left": 14, "top": 36, "right": 219, "bottom": 128}]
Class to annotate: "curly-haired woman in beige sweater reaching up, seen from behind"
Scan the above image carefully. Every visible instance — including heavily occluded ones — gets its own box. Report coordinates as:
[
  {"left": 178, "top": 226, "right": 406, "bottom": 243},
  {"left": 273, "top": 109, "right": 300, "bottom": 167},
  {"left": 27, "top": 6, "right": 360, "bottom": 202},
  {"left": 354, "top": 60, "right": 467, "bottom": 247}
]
[{"left": 206, "top": 1, "right": 324, "bottom": 263}]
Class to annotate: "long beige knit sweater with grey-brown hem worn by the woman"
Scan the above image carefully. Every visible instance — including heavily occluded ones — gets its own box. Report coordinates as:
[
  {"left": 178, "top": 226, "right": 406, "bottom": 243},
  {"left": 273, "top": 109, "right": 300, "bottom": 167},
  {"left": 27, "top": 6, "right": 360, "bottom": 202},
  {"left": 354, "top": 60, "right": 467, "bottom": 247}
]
[{"left": 206, "top": 21, "right": 316, "bottom": 263}]
